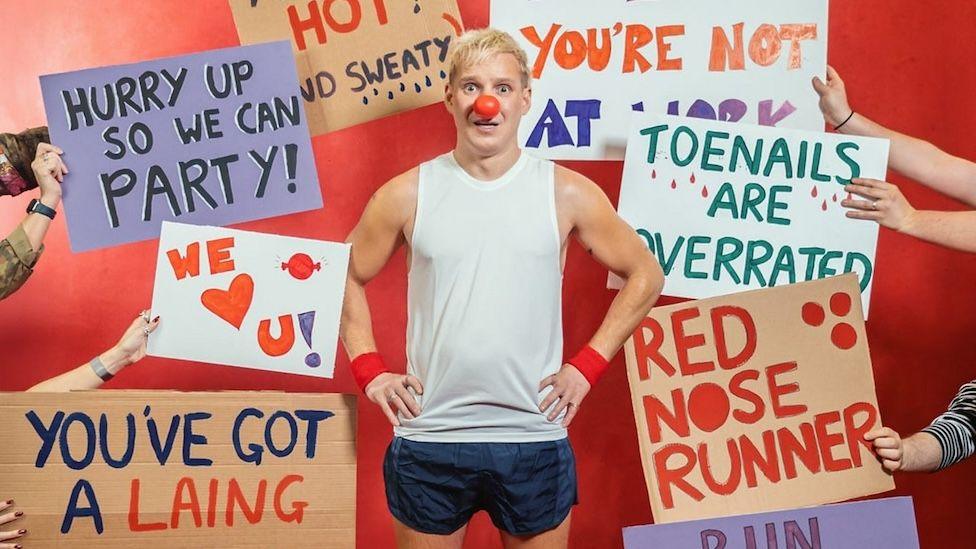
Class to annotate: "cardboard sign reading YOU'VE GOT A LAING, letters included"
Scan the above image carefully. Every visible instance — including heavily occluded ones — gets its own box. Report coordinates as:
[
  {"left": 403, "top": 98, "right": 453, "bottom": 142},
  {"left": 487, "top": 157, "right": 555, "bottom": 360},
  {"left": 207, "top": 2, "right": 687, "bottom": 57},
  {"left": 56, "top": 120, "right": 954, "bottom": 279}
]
[{"left": 0, "top": 391, "right": 356, "bottom": 549}]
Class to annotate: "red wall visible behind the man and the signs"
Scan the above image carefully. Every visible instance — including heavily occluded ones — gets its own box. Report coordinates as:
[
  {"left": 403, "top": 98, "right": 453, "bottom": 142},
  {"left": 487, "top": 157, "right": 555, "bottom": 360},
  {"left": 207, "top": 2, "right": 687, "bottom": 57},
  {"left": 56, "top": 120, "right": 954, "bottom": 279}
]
[{"left": 0, "top": 0, "right": 976, "bottom": 548}]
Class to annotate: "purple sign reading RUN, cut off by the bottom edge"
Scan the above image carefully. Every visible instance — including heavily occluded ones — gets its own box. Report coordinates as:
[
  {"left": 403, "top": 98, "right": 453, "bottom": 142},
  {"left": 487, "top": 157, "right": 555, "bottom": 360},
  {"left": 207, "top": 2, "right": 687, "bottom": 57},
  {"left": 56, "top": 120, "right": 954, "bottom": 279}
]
[{"left": 624, "top": 497, "right": 918, "bottom": 549}]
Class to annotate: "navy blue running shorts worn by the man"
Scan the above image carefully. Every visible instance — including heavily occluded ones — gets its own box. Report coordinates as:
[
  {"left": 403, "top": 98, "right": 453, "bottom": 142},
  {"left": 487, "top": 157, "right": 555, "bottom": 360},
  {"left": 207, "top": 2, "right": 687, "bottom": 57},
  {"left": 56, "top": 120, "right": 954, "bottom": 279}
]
[{"left": 383, "top": 437, "right": 578, "bottom": 536}]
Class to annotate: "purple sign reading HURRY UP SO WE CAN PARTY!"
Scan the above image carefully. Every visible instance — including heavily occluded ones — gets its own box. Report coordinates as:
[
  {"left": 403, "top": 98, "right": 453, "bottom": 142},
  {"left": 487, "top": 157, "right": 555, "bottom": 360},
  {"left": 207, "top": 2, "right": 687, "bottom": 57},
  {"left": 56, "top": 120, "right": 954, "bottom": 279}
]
[{"left": 41, "top": 42, "right": 322, "bottom": 252}]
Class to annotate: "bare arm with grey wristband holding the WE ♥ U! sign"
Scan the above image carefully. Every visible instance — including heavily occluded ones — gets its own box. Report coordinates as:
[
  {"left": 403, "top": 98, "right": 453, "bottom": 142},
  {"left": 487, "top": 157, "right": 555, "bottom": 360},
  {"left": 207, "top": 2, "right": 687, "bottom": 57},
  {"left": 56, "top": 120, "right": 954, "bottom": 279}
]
[{"left": 27, "top": 311, "right": 159, "bottom": 393}]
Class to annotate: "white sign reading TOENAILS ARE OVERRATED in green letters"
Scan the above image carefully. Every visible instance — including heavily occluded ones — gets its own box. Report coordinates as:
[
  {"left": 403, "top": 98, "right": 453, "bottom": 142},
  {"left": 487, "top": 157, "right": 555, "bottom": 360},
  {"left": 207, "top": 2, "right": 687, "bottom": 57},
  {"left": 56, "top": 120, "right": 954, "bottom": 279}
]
[{"left": 611, "top": 114, "right": 888, "bottom": 315}]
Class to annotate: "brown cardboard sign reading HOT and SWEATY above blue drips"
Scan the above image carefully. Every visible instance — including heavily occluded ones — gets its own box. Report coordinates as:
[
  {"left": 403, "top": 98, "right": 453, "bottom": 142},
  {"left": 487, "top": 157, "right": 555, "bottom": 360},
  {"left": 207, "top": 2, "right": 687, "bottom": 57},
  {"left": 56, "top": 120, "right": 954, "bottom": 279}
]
[{"left": 229, "top": 0, "right": 462, "bottom": 135}]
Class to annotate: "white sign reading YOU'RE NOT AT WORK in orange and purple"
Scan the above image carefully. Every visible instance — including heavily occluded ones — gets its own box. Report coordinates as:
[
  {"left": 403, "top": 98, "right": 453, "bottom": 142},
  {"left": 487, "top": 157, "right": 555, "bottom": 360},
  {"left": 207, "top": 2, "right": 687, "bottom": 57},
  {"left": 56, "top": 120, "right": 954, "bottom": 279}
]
[{"left": 491, "top": 0, "right": 827, "bottom": 160}]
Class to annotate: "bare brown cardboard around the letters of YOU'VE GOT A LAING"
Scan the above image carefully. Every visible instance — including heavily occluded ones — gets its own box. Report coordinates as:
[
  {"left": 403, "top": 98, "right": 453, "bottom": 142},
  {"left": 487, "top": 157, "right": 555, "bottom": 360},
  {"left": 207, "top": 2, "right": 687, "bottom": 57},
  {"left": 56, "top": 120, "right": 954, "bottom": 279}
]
[{"left": 0, "top": 391, "right": 356, "bottom": 548}]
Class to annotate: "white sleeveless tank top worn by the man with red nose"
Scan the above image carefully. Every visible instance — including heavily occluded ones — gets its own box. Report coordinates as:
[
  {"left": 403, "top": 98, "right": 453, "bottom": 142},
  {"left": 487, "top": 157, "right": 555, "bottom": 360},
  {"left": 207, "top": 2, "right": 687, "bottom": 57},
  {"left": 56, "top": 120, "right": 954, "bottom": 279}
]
[{"left": 394, "top": 152, "right": 566, "bottom": 442}]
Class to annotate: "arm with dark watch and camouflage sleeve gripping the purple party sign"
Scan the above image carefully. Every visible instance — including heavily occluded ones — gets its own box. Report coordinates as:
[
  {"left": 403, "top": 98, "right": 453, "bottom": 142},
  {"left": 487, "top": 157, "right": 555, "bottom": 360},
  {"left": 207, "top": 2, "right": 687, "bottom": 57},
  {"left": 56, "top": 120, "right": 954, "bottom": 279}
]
[{"left": 0, "top": 143, "right": 68, "bottom": 299}]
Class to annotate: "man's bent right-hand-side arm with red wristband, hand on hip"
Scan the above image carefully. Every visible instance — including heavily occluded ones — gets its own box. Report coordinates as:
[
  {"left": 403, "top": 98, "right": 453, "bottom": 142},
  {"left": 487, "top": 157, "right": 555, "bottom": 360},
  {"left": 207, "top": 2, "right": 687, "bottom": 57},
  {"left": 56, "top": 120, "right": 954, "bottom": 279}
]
[{"left": 539, "top": 166, "right": 664, "bottom": 427}]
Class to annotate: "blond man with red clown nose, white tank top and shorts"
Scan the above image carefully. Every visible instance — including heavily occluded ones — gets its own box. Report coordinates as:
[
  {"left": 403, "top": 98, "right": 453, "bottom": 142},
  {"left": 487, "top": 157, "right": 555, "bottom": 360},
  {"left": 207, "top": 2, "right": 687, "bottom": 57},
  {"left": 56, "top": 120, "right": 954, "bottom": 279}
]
[{"left": 341, "top": 29, "right": 664, "bottom": 547}]
